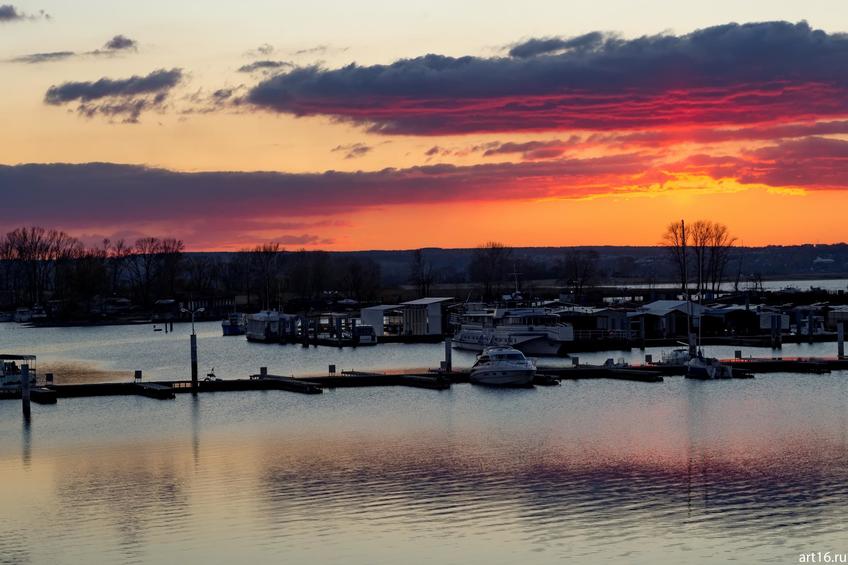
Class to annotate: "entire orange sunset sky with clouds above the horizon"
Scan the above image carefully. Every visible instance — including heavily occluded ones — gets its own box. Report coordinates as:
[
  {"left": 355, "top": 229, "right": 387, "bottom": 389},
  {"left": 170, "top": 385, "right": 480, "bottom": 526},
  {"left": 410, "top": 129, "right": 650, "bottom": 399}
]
[{"left": 0, "top": 0, "right": 848, "bottom": 250}]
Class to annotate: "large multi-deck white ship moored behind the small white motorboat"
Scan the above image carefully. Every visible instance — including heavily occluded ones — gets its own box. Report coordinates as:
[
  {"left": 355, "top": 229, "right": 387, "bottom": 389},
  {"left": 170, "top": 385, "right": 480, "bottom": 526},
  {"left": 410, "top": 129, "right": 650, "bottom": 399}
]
[{"left": 453, "top": 308, "right": 574, "bottom": 356}]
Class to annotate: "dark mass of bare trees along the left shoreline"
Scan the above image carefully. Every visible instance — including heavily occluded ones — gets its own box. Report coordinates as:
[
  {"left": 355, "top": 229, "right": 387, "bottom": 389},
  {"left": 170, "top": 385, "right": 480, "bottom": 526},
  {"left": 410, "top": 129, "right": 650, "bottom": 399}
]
[{"left": 0, "top": 227, "right": 380, "bottom": 319}]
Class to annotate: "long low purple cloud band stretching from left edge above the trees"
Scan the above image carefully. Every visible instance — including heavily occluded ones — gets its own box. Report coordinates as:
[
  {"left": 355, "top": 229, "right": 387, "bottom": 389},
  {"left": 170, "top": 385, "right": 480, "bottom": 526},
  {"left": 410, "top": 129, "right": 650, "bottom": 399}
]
[{"left": 0, "top": 155, "right": 649, "bottom": 232}]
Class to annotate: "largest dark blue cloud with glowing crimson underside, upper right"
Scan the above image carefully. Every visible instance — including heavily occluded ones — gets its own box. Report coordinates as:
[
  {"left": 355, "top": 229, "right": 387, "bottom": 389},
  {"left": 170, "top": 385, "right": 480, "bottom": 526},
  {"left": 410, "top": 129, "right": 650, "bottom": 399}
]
[{"left": 248, "top": 22, "right": 848, "bottom": 135}]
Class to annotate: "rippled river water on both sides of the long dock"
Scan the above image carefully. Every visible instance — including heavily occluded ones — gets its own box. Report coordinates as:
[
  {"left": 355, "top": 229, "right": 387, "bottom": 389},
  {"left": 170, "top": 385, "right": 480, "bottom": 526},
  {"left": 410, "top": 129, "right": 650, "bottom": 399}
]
[{"left": 0, "top": 324, "right": 848, "bottom": 565}]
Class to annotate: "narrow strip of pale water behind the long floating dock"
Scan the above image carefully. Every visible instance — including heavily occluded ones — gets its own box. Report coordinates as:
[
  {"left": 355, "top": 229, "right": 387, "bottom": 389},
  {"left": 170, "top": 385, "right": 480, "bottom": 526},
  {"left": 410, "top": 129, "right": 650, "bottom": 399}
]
[{"left": 0, "top": 322, "right": 836, "bottom": 383}]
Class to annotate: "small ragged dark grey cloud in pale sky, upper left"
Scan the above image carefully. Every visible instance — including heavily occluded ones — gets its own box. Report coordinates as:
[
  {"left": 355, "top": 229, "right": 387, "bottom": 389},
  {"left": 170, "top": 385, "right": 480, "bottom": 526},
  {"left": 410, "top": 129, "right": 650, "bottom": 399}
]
[{"left": 44, "top": 69, "right": 183, "bottom": 122}]
